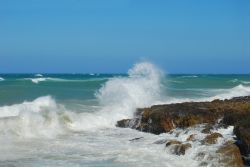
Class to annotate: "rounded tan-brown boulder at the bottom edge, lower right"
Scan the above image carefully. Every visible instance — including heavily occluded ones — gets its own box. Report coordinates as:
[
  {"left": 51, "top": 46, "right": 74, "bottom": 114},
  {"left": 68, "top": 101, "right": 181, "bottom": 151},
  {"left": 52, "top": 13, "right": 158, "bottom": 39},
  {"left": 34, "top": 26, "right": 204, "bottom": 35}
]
[{"left": 217, "top": 143, "right": 244, "bottom": 167}]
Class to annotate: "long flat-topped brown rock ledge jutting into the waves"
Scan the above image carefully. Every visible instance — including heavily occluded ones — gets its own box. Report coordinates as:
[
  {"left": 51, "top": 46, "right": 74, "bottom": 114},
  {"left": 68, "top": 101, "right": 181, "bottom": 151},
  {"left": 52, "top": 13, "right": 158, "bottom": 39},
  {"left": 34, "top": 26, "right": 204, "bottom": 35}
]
[{"left": 117, "top": 96, "right": 250, "bottom": 134}]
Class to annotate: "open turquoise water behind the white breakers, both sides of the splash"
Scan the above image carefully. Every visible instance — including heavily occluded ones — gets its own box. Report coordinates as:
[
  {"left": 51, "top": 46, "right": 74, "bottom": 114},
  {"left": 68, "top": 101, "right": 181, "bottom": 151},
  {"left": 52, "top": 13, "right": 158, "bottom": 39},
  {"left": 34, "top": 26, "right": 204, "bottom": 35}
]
[{"left": 0, "top": 74, "right": 250, "bottom": 105}]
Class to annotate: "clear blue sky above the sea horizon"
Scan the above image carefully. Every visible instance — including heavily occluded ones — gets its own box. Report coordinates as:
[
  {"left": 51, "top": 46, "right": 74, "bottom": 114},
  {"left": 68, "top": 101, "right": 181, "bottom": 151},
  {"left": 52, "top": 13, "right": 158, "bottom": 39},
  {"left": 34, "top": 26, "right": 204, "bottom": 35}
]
[{"left": 0, "top": 0, "right": 250, "bottom": 73}]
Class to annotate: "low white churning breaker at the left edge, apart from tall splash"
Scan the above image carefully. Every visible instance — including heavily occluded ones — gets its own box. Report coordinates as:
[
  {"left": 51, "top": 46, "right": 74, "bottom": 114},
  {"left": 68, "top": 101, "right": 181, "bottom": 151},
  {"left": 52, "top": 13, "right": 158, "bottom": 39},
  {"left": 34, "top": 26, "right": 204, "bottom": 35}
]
[{"left": 0, "top": 96, "right": 67, "bottom": 137}]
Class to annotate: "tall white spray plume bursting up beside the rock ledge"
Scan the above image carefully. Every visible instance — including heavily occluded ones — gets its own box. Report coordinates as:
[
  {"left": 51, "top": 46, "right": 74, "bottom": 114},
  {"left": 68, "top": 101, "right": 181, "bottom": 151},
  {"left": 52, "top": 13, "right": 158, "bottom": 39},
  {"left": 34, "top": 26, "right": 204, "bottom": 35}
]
[{"left": 69, "top": 62, "right": 163, "bottom": 130}]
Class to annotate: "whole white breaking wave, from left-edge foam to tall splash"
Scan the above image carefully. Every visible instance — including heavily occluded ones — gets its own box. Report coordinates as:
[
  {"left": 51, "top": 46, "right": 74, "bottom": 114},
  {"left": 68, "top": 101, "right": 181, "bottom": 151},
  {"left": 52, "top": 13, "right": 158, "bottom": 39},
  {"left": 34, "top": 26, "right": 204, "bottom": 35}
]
[{"left": 0, "top": 62, "right": 162, "bottom": 137}]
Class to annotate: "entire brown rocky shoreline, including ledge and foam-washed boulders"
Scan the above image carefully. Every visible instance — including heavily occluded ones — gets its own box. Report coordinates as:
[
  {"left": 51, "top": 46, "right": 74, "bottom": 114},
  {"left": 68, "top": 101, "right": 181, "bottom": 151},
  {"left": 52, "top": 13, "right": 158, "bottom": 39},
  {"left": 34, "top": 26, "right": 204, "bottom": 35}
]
[{"left": 117, "top": 96, "right": 250, "bottom": 167}]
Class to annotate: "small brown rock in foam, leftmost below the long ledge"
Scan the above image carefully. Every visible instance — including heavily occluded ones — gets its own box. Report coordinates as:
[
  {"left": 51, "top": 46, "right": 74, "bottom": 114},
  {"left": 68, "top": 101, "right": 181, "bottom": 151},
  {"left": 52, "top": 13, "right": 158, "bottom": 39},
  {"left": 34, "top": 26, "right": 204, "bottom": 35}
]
[{"left": 166, "top": 140, "right": 192, "bottom": 155}]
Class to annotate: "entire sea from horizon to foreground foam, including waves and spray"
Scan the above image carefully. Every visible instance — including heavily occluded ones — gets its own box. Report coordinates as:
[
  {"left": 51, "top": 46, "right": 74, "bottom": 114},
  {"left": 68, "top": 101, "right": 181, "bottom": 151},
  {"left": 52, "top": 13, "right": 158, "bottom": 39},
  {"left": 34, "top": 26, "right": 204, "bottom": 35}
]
[{"left": 0, "top": 62, "right": 250, "bottom": 167}]
